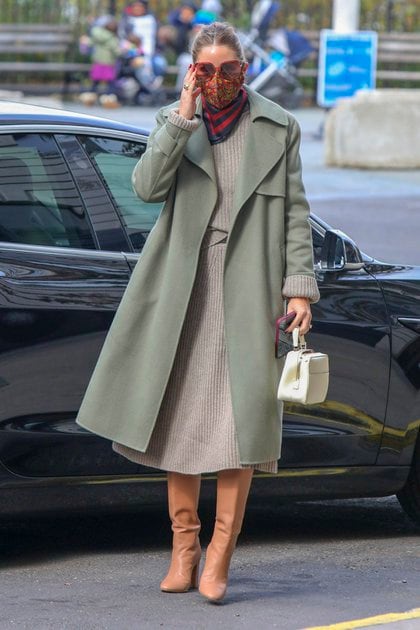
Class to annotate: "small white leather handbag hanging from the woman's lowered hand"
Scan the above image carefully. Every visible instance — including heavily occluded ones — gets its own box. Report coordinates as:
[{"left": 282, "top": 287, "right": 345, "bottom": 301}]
[{"left": 277, "top": 327, "right": 329, "bottom": 405}]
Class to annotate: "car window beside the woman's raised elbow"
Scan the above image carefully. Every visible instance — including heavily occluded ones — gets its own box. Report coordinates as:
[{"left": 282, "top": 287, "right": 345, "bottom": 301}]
[{"left": 79, "top": 136, "right": 162, "bottom": 251}]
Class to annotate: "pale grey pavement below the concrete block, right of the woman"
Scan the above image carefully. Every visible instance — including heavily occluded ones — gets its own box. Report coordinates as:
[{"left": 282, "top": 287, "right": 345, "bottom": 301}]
[{"left": 294, "top": 109, "right": 420, "bottom": 266}]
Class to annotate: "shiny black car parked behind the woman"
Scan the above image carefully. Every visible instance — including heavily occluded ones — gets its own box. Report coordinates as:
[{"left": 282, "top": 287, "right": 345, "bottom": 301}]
[{"left": 0, "top": 102, "right": 420, "bottom": 523}]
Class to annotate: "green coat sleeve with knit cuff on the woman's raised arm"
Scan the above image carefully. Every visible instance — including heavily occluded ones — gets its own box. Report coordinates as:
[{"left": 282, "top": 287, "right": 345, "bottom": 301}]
[{"left": 132, "top": 109, "right": 199, "bottom": 202}]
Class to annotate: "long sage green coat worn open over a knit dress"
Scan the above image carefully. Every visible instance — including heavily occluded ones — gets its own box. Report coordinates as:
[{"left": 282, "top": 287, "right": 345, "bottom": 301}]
[{"left": 77, "top": 89, "right": 319, "bottom": 464}]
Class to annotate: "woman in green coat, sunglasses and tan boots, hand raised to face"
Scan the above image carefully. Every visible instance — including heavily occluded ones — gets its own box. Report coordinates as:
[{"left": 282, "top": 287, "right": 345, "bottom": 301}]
[{"left": 78, "top": 22, "right": 319, "bottom": 602}]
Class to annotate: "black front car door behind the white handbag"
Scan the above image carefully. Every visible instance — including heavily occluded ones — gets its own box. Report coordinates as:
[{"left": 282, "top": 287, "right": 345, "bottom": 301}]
[{"left": 279, "top": 220, "right": 390, "bottom": 468}]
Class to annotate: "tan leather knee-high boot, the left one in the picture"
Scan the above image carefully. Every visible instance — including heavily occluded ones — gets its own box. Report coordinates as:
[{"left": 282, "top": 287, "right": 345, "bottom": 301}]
[{"left": 160, "top": 472, "right": 201, "bottom": 593}]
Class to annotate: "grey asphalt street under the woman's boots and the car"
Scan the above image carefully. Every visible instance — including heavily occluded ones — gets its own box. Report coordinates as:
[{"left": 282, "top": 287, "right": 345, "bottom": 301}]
[{"left": 0, "top": 491, "right": 420, "bottom": 630}]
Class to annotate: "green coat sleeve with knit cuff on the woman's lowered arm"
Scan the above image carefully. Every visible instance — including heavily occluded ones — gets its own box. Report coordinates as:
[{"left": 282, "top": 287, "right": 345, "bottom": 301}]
[{"left": 282, "top": 117, "right": 320, "bottom": 303}]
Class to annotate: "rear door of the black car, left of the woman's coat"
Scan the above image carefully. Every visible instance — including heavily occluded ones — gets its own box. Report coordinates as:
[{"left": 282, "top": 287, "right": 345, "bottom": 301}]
[{"left": 0, "top": 128, "right": 144, "bottom": 477}]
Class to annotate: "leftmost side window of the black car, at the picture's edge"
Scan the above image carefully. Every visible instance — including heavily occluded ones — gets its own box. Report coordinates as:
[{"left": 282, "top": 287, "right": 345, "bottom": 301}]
[{"left": 0, "top": 134, "right": 96, "bottom": 249}]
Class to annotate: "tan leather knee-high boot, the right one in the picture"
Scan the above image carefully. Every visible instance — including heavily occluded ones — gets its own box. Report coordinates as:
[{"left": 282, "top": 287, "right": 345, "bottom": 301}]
[{"left": 199, "top": 468, "right": 253, "bottom": 602}]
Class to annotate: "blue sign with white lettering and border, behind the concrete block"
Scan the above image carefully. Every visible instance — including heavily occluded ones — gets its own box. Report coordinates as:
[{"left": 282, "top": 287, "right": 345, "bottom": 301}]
[{"left": 317, "top": 29, "right": 378, "bottom": 107}]
